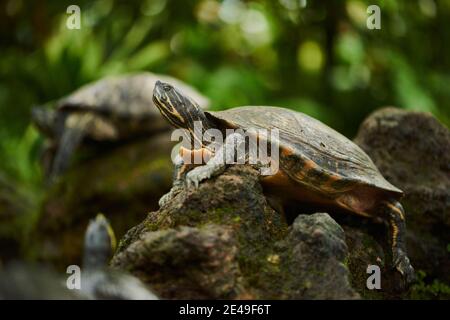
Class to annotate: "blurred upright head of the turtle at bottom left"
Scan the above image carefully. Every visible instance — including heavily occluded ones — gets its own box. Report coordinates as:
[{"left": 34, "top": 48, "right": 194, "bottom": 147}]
[{"left": 83, "top": 213, "right": 116, "bottom": 269}]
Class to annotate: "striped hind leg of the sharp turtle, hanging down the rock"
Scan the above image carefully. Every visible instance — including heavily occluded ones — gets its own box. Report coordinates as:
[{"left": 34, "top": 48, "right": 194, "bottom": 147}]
[{"left": 386, "top": 201, "right": 416, "bottom": 285}]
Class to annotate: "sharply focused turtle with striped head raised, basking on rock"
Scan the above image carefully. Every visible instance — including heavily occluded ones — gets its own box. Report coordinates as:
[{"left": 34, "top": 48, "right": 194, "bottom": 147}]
[{"left": 153, "top": 81, "right": 416, "bottom": 285}]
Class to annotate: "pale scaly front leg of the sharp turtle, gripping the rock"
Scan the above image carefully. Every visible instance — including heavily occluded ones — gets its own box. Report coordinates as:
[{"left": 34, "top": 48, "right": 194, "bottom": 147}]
[{"left": 186, "top": 133, "right": 245, "bottom": 188}]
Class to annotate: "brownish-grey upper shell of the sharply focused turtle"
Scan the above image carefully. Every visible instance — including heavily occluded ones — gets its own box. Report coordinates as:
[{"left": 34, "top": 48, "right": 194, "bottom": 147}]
[{"left": 208, "top": 106, "right": 402, "bottom": 193}]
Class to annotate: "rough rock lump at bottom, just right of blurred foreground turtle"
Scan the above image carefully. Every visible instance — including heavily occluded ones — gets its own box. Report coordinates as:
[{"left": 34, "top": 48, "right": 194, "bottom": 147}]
[{"left": 114, "top": 224, "right": 243, "bottom": 299}]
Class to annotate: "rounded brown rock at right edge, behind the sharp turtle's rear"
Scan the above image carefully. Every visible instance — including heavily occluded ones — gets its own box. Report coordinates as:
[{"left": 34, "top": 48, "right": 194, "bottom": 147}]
[{"left": 355, "top": 108, "right": 450, "bottom": 298}]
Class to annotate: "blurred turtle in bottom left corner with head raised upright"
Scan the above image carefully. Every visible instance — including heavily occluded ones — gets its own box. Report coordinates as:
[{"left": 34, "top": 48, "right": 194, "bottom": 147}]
[{"left": 0, "top": 214, "right": 158, "bottom": 300}]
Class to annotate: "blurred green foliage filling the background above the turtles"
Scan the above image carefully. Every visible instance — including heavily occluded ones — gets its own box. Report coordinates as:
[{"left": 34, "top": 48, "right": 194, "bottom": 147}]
[{"left": 0, "top": 0, "right": 450, "bottom": 185}]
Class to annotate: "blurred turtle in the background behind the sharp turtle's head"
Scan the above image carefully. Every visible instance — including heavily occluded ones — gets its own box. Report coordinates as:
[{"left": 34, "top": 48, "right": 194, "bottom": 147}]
[{"left": 31, "top": 72, "right": 209, "bottom": 181}]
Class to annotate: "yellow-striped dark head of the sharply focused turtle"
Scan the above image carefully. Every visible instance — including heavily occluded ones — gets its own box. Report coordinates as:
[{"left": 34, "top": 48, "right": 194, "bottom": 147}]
[{"left": 153, "top": 81, "right": 208, "bottom": 131}]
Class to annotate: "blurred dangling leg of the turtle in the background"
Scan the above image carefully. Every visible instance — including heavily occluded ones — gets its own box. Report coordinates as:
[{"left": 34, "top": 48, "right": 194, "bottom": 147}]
[{"left": 48, "top": 114, "right": 93, "bottom": 183}]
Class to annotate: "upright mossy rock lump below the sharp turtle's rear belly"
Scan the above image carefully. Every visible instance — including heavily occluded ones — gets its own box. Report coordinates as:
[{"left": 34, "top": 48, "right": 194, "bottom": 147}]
[{"left": 274, "top": 213, "right": 359, "bottom": 299}]
